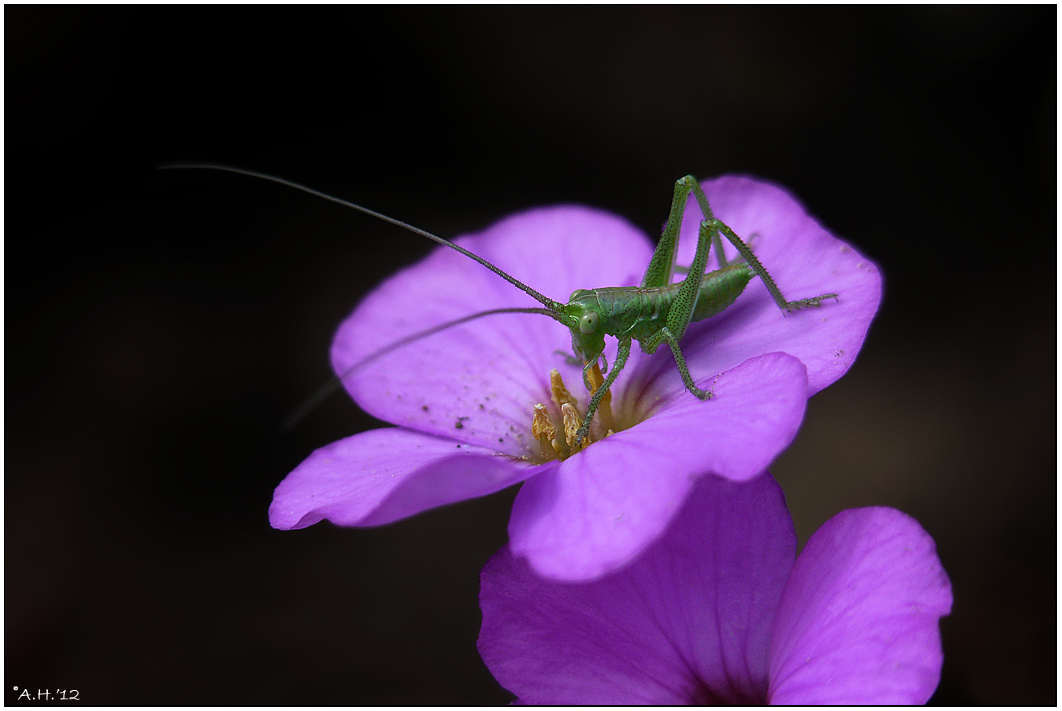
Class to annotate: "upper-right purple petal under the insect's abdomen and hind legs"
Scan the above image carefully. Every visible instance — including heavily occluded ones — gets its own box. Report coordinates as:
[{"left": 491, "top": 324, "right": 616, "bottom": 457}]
[{"left": 653, "top": 175, "right": 881, "bottom": 394}]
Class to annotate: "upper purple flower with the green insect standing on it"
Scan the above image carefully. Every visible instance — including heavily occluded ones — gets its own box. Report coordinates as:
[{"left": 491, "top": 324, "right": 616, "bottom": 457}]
[{"left": 270, "top": 176, "right": 881, "bottom": 579}]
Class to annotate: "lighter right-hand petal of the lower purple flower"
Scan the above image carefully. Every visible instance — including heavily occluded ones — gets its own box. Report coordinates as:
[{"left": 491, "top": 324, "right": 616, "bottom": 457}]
[{"left": 770, "top": 508, "right": 952, "bottom": 705}]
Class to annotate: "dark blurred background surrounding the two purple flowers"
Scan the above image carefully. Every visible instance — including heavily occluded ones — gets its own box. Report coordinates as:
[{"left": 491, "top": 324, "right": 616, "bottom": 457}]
[{"left": 4, "top": 6, "right": 1057, "bottom": 705}]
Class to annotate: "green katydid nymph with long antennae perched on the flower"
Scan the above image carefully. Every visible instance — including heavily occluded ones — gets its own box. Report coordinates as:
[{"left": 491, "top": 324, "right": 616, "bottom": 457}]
[{"left": 166, "top": 164, "right": 838, "bottom": 452}]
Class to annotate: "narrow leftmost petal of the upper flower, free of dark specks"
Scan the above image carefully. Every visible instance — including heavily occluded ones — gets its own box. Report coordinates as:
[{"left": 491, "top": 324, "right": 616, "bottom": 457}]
[{"left": 269, "top": 427, "right": 550, "bottom": 530}]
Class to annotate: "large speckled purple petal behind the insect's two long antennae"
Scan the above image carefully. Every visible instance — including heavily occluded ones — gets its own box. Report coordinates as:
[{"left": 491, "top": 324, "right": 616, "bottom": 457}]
[{"left": 331, "top": 207, "right": 652, "bottom": 457}]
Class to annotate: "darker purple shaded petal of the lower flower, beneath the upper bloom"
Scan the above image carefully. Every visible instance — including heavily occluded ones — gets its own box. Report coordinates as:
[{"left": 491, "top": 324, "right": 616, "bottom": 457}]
[{"left": 478, "top": 471, "right": 797, "bottom": 705}]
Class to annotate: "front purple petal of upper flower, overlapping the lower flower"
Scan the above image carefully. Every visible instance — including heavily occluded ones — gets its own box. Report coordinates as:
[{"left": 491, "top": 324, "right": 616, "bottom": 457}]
[{"left": 509, "top": 353, "right": 807, "bottom": 580}]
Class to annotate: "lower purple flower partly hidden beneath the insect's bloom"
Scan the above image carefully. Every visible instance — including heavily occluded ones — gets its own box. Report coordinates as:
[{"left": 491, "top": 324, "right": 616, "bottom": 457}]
[{"left": 478, "top": 472, "right": 952, "bottom": 705}]
